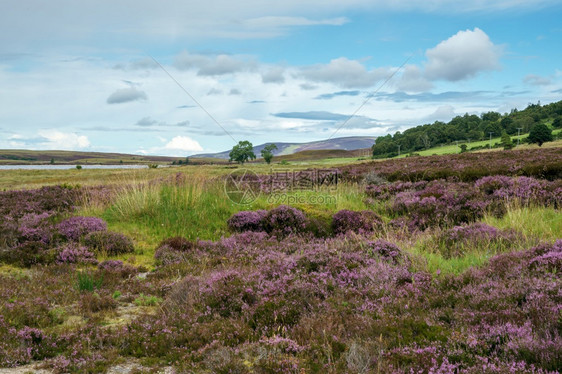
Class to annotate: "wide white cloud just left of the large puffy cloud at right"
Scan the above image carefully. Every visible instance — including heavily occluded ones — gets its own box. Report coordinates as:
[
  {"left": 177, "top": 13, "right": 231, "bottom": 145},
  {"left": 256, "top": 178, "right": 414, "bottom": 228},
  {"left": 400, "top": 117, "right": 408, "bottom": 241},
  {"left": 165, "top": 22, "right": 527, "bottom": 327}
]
[{"left": 301, "top": 57, "right": 389, "bottom": 88}]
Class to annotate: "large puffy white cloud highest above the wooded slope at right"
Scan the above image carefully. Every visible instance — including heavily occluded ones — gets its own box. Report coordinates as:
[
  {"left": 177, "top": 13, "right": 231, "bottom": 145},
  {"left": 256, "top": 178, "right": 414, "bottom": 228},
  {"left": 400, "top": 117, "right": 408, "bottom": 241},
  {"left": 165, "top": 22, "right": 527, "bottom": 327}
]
[{"left": 425, "top": 28, "right": 502, "bottom": 81}]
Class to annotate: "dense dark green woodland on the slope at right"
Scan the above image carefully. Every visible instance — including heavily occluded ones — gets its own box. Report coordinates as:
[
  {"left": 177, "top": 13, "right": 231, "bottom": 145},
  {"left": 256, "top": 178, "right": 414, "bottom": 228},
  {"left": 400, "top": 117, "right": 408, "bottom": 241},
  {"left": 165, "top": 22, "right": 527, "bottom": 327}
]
[{"left": 373, "top": 101, "right": 562, "bottom": 158}]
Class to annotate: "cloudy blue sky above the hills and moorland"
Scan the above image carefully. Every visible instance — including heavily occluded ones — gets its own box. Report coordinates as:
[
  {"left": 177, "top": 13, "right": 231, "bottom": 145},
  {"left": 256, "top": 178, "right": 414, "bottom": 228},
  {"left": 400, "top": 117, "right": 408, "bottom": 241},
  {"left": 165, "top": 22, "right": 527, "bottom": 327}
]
[{"left": 0, "top": 0, "right": 562, "bottom": 156}]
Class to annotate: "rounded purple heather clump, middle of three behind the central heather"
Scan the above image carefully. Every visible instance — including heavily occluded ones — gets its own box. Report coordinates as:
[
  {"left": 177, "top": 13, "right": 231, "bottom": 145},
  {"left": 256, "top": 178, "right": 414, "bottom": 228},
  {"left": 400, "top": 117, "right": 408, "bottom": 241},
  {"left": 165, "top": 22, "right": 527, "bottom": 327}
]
[{"left": 263, "top": 205, "right": 307, "bottom": 237}]
